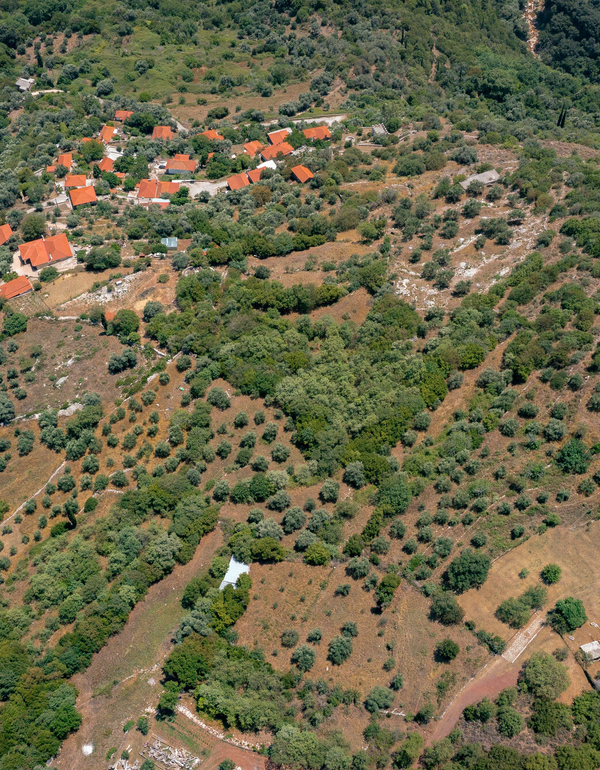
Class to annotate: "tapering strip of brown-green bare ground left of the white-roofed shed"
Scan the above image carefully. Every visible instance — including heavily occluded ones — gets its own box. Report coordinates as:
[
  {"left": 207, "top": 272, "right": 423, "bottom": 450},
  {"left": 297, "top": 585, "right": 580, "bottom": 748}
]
[{"left": 54, "top": 529, "right": 227, "bottom": 770}]
